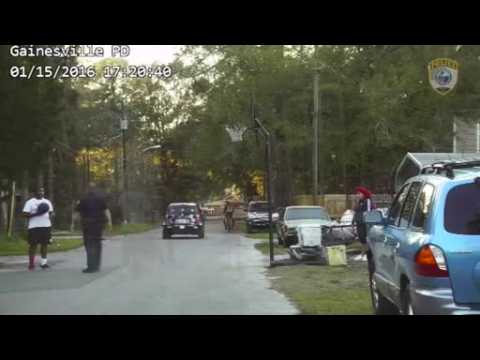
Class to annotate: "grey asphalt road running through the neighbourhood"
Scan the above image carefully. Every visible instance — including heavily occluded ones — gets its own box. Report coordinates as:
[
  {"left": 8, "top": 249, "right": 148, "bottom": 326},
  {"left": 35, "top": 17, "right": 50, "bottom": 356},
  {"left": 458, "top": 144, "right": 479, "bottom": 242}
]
[{"left": 0, "top": 222, "right": 298, "bottom": 315}]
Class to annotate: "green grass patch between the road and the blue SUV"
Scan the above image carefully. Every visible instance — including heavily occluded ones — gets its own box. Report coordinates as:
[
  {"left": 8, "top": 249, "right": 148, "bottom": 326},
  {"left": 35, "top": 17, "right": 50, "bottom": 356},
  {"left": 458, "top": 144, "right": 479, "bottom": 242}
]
[{"left": 268, "top": 263, "right": 372, "bottom": 315}]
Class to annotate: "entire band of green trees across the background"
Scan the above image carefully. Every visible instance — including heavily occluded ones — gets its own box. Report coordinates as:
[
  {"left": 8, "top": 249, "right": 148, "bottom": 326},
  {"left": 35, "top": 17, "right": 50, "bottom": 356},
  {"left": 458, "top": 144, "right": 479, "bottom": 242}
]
[{"left": 0, "top": 45, "right": 480, "bottom": 228}]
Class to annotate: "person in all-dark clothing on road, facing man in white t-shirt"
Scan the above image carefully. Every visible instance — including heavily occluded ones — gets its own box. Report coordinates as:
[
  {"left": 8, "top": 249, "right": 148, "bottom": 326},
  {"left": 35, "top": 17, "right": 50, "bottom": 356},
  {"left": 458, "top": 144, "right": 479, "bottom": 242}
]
[{"left": 75, "top": 183, "right": 112, "bottom": 273}]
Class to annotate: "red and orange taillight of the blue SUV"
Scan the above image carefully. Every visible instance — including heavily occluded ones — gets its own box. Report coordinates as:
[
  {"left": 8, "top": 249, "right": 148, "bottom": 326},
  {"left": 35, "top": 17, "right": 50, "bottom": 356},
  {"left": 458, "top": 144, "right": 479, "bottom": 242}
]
[{"left": 415, "top": 245, "right": 448, "bottom": 277}]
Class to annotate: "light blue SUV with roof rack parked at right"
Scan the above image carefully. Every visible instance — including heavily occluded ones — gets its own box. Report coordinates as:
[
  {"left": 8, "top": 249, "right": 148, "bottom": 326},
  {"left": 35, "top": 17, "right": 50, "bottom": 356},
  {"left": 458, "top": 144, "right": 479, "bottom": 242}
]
[{"left": 365, "top": 161, "right": 480, "bottom": 315}]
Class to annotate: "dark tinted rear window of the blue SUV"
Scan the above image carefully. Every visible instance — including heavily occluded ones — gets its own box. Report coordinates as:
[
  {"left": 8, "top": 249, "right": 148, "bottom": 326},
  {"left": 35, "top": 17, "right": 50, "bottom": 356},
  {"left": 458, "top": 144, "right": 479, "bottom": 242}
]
[{"left": 444, "top": 184, "right": 480, "bottom": 235}]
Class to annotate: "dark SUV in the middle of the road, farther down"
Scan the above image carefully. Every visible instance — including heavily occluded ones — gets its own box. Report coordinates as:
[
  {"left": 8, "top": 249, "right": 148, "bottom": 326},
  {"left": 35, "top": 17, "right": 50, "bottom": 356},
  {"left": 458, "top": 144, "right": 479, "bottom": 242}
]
[{"left": 163, "top": 203, "right": 205, "bottom": 239}]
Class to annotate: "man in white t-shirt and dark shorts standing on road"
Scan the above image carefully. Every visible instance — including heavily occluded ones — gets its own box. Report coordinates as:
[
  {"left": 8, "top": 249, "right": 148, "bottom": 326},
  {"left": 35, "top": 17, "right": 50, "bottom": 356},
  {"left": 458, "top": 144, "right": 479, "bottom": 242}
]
[{"left": 23, "top": 188, "right": 53, "bottom": 270}]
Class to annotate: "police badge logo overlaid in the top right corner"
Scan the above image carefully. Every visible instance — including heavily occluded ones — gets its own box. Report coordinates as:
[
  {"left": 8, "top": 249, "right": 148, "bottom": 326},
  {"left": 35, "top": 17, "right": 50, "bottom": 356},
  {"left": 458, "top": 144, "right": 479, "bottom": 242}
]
[{"left": 428, "top": 59, "right": 458, "bottom": 95}]
